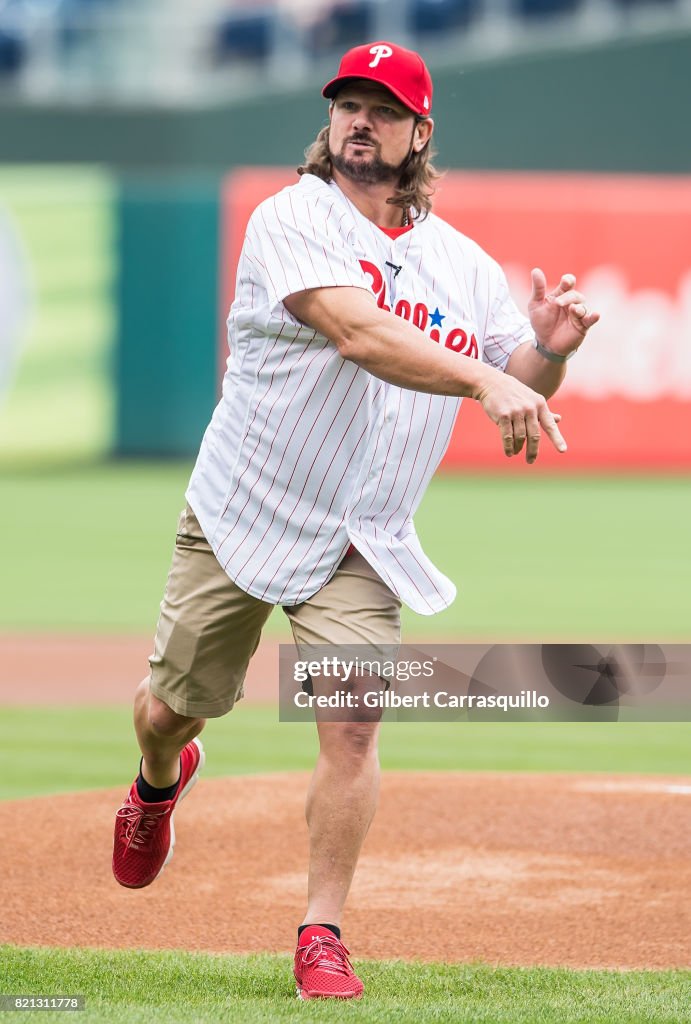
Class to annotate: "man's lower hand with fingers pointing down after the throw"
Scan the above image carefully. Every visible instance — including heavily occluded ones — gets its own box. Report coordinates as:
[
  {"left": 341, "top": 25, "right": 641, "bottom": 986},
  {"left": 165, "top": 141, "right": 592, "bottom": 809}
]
[{"left": 474, "top": 372, "right": 566, "bottom": 464}]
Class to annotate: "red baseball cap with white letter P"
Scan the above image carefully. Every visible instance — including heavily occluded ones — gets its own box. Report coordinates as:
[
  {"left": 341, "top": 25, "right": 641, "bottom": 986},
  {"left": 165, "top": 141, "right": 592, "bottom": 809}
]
[{"left": 321, "top": 42, "right": 432, "bottom": 118}]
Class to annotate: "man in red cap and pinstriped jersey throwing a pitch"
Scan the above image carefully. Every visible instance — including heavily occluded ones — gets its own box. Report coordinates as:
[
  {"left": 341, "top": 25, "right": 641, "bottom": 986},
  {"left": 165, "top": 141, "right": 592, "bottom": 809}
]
[{"left": 113, "top": 42, "right": 598, "bottom": 998}]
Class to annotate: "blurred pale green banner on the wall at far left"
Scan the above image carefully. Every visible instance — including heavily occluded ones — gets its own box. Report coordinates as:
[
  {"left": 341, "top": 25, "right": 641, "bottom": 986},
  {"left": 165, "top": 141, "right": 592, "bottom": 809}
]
[{"left": 0, "top": 165, "right": 117, "bottom": 466}]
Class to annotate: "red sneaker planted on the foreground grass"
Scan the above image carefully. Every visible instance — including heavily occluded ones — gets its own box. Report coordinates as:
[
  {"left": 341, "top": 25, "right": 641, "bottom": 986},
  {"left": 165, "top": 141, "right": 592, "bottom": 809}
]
[{"left": 293, "top": 925, "right": 364, "bottom": 999}]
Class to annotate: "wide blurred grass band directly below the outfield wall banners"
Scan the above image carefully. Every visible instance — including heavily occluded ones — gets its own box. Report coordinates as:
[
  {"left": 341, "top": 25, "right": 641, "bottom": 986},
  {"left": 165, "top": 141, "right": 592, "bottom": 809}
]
[{"left": 0, "top": 462, "right": 691, "bottom": 642}]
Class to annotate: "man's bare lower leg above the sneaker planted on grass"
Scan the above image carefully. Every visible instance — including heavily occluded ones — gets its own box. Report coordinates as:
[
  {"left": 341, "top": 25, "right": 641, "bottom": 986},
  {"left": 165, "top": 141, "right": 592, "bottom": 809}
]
[{"left": 303, "top": 722, "right": 379, "bottom": 926}]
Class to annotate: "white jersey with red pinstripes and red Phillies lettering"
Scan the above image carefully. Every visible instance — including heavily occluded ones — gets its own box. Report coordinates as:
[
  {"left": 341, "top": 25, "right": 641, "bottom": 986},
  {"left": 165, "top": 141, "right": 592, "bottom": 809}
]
[{"left": 186, "top": 175, "right": 533, "bottom": 614}]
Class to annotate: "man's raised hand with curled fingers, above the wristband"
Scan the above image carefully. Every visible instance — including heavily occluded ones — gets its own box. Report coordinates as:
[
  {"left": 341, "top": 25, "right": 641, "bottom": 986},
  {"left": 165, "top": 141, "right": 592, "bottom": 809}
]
[{"left": 528, "top": 267, "right": 600, "bottom": 355}]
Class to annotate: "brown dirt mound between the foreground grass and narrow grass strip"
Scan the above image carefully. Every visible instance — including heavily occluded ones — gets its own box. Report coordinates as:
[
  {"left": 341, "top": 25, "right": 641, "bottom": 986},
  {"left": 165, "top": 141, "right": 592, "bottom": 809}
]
[{"left": 0, "top": 773, "right": 691, "bottom": 968}]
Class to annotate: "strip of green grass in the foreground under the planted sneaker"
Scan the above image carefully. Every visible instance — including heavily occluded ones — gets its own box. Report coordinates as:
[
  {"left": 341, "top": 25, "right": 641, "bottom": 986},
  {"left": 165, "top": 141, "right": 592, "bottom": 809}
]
[{"left": 0, "top": 946, "right": 691, "bottom": 1024}]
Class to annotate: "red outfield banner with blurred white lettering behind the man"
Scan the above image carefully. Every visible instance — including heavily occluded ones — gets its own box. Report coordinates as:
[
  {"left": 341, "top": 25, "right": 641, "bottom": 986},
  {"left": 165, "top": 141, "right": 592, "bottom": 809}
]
[{"left": 224, "top": 168, "right": 691, "bottom": 472}]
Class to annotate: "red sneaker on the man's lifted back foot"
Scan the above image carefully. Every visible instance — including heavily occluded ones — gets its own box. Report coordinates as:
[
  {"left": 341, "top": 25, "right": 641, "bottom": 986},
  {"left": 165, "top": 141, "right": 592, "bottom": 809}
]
[{"left": 113, "top": 739, "right": 205, "bottom": 889}]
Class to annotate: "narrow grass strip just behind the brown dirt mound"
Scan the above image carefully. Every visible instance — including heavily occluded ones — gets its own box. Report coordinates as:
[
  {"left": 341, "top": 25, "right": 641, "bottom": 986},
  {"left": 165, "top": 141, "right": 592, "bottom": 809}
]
[{"left": 0, "top": 703, "right": 691, "bottom": 800}]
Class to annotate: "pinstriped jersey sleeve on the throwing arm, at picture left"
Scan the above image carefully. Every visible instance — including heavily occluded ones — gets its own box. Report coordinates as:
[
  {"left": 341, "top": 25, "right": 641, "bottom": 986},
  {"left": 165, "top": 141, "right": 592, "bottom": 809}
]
[{"left": 246, "top": 187, "right": 370, "bottom": 307}]
